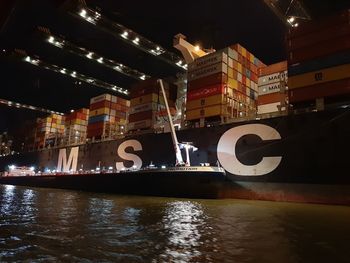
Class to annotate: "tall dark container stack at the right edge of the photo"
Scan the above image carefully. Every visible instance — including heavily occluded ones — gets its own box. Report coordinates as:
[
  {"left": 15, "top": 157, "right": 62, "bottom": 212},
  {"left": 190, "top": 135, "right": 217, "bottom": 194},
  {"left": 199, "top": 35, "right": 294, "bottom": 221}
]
[{"left": 287, "top": 10, "right": 350, "bottom": 109}]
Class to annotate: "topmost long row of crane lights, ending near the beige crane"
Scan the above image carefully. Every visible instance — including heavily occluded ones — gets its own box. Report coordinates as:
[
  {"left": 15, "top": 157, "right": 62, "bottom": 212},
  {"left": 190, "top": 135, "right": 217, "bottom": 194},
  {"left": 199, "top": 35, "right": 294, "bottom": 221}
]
[{"left": 78, "top": 8, "right": 187, "bottom": 70}]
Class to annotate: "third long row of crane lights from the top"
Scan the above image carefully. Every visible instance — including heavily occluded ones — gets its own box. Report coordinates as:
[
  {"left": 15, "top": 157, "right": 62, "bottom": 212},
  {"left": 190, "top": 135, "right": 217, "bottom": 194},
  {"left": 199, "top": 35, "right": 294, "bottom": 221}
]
[{"left": 24, "top": 56, "right": 129, "bottom": 95}]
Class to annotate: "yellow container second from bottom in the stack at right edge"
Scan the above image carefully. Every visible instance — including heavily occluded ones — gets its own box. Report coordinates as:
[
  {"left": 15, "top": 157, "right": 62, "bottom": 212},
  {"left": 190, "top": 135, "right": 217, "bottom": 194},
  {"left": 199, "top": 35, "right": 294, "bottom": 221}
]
[{"left": 288, "top": 64, "right": 350, "bottom": 89}]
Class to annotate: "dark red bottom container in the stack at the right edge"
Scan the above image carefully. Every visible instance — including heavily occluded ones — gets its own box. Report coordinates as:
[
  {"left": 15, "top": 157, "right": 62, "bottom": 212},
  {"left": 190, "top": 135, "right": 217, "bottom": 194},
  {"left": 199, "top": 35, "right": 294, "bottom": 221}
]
[{"left": 288, "top": 78, "right": 350, "bottom": 103}]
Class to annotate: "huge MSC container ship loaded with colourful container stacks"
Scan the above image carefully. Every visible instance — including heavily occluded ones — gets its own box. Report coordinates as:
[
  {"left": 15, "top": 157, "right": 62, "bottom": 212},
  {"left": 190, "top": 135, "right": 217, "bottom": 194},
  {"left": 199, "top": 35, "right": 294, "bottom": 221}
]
[{"left": 0, "top": 6, "right": 350, "bottom": 205}]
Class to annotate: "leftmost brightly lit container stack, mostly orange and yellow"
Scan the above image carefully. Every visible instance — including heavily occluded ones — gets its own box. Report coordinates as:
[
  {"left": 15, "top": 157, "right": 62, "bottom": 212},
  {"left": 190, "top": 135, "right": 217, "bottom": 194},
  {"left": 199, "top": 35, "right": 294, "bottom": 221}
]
[{"left": 34, "top": 114, "right": 65, "bottom": 149}]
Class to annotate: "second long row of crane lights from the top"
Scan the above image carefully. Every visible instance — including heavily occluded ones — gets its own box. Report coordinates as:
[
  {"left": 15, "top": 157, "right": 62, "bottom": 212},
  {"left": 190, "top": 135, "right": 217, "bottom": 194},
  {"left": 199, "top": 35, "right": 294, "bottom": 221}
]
[{"left": 47, "top": 35, "right": 150, "bottom": 80}]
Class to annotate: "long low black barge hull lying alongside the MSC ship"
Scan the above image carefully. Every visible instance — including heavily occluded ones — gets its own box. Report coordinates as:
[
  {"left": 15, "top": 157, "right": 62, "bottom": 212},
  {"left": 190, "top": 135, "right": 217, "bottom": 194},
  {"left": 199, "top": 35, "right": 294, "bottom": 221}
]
[{"left": 0, "top": 170, "right": 227, "bottom": 199}]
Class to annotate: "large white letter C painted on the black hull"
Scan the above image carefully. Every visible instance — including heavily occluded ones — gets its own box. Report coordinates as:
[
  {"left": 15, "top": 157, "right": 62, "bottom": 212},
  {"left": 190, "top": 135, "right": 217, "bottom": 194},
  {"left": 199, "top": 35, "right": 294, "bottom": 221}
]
[{"left": 217, "top": 124, "right": 282, "bottom": 176}]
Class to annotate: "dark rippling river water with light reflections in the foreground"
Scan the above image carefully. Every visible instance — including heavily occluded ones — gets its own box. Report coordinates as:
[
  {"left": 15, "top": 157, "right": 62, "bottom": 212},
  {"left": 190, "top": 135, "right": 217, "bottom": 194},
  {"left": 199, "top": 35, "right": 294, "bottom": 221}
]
[{"left": 0, "top": 185, "right": 350, "bottom": 262}]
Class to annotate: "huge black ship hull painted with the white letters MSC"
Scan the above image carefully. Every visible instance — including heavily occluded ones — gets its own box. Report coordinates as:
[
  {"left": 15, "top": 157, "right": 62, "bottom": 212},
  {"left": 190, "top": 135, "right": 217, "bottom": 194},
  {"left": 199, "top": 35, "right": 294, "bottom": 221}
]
[{"left": 0, "top": 109, "right": 350, "bottom": 205}]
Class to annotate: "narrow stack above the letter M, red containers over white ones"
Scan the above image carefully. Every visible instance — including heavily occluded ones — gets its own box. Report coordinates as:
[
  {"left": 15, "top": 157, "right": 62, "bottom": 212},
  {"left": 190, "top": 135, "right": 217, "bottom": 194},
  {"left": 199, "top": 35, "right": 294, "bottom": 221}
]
[{"left": 63, "top": 108, "right": 89, "bottom": 145}]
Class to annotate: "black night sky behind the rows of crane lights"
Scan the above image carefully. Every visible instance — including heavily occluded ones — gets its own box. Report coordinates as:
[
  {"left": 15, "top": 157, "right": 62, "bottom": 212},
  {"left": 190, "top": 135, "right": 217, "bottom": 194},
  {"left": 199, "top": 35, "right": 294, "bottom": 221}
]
[{"left": 0, "top": 0, "right": 350, "bottom": 131}]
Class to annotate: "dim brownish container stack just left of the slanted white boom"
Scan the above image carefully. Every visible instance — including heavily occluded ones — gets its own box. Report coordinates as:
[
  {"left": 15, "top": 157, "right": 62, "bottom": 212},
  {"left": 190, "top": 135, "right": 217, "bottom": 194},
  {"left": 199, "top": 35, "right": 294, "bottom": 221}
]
[{"left": 128, "top": 79, "right": 175, "bottom": 132}]
